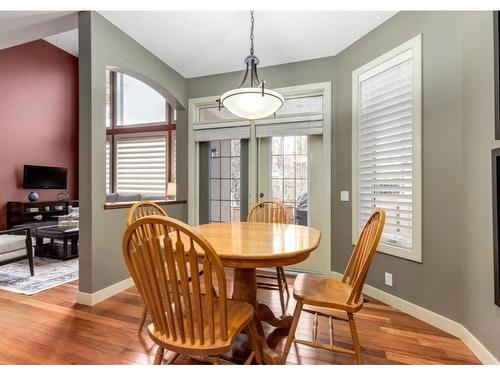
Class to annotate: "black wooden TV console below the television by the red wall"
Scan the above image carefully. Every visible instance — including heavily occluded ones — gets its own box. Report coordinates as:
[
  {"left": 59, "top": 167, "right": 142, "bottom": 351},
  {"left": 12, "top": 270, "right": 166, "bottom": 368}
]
[{"left": 7, "top": 200, "right": 78, "bottom": 229}]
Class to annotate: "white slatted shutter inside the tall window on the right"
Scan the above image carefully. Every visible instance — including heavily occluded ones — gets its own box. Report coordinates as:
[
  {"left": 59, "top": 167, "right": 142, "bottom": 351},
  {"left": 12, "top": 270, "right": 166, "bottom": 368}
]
[{"left": 357, "top": 50, "right": 413, "bottom": 250}]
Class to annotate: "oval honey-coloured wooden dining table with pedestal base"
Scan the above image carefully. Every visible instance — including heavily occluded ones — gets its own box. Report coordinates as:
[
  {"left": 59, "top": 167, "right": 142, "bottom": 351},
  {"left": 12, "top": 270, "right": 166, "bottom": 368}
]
[{"left": 187, "top": 222, "right": 321, "bottom": 364}]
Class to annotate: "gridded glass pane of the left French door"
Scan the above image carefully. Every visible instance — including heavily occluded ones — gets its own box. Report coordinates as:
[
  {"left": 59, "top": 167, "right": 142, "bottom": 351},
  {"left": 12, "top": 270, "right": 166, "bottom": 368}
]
[{"left": 209, "top": 139, "right": 241, "bottom": 222}]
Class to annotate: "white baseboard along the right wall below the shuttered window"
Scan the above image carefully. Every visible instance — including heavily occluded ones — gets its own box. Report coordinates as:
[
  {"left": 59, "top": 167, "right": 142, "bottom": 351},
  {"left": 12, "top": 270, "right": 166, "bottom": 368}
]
[{"left": 331, "top": 271, "right": 500, "bottom": 365}]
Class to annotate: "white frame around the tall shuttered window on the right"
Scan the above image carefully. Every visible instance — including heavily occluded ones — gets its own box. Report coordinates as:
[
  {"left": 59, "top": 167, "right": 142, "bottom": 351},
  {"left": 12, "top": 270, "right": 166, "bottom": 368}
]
[{"left": 352, "top": 34, "right": 422, "bottom": 263}]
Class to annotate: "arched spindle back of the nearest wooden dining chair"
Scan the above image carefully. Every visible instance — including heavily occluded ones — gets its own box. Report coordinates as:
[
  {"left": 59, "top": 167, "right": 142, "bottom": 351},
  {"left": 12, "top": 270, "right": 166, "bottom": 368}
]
[{"left": 122, "top": 216, "right": 228, "bottom": 345}]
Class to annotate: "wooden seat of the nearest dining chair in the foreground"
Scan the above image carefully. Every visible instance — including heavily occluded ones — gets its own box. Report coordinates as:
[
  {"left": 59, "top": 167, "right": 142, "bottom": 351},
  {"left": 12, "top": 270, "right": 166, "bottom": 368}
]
[{"left": 148, "top": 299, "right": 254, "bottom": 355}]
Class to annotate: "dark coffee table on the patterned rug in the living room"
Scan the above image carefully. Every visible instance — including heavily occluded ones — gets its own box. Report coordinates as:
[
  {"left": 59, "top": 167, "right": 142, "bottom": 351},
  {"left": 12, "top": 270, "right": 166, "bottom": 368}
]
[{"left": 35, "top": 225, "right": 78, "bottom": 260}]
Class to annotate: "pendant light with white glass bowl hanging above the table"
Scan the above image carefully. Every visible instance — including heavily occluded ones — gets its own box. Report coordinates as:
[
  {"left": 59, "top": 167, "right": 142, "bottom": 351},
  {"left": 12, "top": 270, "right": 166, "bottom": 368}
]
[{"left": 218, "top": 10, "right": 285, "bottom": 120}]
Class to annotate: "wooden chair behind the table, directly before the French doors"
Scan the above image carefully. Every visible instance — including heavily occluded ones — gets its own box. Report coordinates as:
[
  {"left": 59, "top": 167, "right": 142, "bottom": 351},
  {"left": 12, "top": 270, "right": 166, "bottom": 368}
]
[{"left": 247, "top": 201, "right": 291, "bottom": 314}]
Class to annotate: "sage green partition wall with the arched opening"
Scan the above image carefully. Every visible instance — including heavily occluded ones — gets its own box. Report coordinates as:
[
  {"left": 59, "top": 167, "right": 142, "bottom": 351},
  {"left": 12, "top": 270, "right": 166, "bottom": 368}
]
[{"left": 79, "top": 12, "right": 187, "bottom": 293}]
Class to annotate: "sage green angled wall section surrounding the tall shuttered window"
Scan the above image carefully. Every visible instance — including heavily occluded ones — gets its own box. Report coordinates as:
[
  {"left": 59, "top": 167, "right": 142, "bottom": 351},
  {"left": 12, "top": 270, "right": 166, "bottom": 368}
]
[{"left": 332, "top": 12, "right": 464, "bottom": 321}]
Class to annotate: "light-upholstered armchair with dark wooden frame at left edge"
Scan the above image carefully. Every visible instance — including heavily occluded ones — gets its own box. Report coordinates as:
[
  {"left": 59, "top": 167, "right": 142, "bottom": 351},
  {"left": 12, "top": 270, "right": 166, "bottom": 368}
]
[{"left": 0, "top": 227, "right": 35, "bottom": 276}]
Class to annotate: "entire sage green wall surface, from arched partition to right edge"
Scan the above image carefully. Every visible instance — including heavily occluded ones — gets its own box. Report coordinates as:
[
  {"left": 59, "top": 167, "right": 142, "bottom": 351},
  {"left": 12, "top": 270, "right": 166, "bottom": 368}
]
[{"left": 79, "top": 12, "right": 500, "bottom": 358}]
